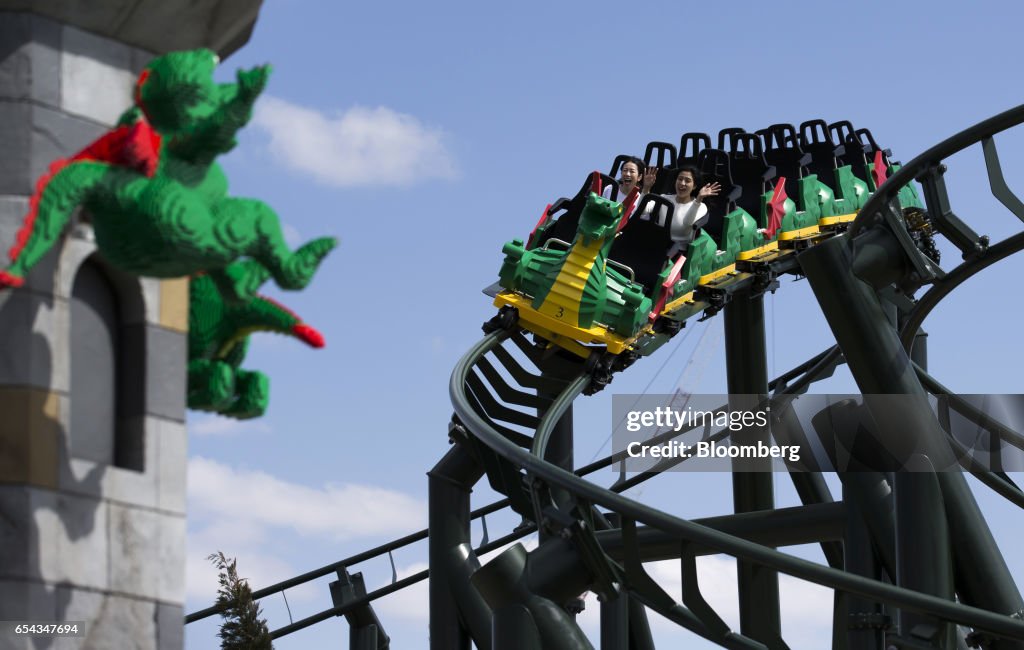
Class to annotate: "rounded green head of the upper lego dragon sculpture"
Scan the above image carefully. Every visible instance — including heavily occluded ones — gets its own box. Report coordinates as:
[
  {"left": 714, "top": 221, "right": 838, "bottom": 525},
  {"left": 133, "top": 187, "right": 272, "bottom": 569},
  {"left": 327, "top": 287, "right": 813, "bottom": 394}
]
[{"left": 134, "top": 49, "right": 223, "bottom": 134}]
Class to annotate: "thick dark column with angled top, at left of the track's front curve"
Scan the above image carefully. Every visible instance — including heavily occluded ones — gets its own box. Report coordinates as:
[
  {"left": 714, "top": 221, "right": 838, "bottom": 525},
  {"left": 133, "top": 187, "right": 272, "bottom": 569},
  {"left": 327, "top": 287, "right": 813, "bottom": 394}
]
[{"left": 427, "top": 443, "right": 492, "bottom": 650}]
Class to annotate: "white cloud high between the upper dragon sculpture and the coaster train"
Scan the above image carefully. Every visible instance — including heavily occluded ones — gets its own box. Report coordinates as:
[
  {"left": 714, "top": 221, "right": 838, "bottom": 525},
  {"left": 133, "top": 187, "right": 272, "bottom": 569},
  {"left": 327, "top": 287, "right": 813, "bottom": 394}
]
[{"left": 253, "top": 95, "right": 457, "bottom": 187}]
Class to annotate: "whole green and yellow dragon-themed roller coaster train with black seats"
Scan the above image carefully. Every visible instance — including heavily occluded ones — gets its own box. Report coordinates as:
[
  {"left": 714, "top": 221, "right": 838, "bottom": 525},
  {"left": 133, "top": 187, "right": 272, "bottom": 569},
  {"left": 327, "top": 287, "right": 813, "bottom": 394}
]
[{"left": 495, "top": 120, "right": 922, "bottom": 357}]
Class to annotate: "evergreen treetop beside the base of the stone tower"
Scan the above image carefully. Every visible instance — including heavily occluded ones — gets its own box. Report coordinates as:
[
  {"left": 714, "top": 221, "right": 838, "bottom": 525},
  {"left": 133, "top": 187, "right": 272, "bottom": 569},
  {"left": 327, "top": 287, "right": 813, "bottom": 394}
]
[{"left": 207, "top": 551, "right": 273, "bottom": 650}]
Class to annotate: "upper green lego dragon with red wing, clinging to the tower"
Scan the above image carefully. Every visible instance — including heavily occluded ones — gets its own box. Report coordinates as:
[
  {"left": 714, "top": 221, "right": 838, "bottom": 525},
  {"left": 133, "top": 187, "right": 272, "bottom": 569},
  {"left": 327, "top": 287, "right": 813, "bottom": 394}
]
[{"left": 0, "top": 49, "right": 336, "bottom": 303}]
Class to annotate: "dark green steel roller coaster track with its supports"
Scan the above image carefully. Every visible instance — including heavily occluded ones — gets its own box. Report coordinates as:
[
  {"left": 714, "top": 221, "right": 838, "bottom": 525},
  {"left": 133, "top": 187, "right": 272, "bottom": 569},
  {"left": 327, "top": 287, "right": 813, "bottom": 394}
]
[{"left": 186, "top": 105, "right": 1024, "bottom": 650}]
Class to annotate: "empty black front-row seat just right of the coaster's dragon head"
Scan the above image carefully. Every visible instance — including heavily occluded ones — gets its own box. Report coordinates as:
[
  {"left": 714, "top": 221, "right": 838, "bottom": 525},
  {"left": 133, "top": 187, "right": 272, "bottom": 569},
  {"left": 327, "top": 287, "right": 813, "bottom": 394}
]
[{"left": 608, "top": 194, "right": 676, "bottom": 295}]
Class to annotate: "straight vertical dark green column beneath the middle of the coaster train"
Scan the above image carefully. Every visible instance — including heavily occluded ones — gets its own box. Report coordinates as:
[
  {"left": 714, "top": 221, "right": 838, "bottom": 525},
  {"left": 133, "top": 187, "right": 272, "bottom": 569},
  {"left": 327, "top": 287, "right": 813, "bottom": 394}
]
[{"left": 724, "top": 294, "right": 781, "bottom": 643}]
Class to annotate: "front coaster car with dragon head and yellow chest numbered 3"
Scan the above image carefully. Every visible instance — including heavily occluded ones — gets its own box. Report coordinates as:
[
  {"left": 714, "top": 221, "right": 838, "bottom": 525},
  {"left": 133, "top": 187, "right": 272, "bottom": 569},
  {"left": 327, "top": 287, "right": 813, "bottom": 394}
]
[{"left": 495, "top": 167, "right": 760, "bottom": 356}]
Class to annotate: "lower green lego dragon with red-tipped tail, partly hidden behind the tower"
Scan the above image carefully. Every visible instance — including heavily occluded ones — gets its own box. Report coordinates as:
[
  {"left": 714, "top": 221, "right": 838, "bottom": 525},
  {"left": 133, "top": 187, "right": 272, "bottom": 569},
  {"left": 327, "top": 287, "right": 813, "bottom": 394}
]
[{"left": 188, "top": 260, "right": 324, "bottom": 420}]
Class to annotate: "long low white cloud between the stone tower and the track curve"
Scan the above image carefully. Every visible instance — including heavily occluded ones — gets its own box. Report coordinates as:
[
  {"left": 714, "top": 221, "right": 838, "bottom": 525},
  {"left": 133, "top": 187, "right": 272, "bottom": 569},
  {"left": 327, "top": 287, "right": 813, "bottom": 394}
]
[{"left": 188, "top": 457, "right": 427, "bottom": 541}]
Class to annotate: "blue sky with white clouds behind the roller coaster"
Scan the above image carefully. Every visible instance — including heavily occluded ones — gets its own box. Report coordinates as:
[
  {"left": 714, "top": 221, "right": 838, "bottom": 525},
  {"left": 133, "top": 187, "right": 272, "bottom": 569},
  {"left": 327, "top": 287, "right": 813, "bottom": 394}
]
[{"left": 186, "top": 0, "right": 1024, "bottom": 650}]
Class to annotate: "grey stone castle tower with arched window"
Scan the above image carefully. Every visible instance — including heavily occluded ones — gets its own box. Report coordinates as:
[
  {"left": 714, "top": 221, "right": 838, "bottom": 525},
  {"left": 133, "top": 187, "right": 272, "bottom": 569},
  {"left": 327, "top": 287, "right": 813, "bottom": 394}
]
[{"left": 0, "top": 0, "right": 260, "bottom": 650}]
